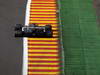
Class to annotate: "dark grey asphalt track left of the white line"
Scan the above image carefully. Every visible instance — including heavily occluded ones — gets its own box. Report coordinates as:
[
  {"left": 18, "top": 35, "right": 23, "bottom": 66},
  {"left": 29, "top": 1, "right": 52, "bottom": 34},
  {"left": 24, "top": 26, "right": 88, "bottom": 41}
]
[{"left": 0, "top": 0, "right": 26, "bottom": 75}]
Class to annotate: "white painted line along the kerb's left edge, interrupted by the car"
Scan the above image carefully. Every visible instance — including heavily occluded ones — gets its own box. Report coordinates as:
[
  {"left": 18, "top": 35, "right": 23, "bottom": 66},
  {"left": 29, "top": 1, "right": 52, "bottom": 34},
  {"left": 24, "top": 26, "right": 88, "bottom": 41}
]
[{"left": 22, "top": 0, "right": 31, "bottom": 75}]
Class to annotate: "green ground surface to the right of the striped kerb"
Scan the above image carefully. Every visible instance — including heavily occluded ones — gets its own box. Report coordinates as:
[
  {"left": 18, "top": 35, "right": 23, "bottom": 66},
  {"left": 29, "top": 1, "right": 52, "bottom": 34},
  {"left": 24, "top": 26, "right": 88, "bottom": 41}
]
[{"left": 60, "top": 0, "right": 100, "bottom": 75}]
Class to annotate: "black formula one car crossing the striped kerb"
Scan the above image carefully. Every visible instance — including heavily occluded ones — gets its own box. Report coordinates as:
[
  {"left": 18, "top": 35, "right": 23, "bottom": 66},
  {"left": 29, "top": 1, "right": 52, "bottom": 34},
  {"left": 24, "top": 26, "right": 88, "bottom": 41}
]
[{"left": 15, "top": 24, "right": 53, "bottom": 38}]
